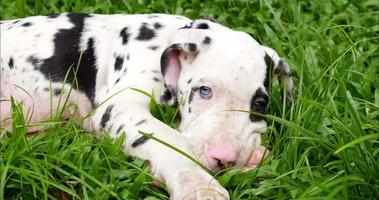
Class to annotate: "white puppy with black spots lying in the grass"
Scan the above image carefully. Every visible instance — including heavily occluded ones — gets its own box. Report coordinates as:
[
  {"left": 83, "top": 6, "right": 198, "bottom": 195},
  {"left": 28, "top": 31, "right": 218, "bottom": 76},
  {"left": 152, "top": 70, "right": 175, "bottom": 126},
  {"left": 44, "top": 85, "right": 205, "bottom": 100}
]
[{"left": 0, "top": 13, "right": 292, "bottom": 199}]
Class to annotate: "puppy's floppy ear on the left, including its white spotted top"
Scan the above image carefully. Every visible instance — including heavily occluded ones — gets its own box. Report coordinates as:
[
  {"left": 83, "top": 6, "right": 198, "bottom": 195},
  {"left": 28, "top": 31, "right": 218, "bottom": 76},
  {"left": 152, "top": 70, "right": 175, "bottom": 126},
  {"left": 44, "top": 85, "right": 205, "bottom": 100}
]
[{"left": 161, "top": 29, "right": 210, "bottom": 104}]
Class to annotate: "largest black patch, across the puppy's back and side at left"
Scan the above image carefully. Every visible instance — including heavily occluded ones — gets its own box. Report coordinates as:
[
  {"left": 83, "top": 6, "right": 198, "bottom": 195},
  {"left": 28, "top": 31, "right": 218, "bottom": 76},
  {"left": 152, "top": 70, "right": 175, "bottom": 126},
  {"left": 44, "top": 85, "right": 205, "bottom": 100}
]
[{"left": 39, "top": 13, "right": 97, "bottom": 104}]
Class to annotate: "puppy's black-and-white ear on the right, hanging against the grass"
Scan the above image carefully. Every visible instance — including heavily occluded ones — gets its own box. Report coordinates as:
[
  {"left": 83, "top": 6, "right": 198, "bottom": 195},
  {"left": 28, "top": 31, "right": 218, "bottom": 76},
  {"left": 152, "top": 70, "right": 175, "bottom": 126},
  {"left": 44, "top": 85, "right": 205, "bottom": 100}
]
[{"left": 262, "top": 46, "right": 293, "bottom": 106}]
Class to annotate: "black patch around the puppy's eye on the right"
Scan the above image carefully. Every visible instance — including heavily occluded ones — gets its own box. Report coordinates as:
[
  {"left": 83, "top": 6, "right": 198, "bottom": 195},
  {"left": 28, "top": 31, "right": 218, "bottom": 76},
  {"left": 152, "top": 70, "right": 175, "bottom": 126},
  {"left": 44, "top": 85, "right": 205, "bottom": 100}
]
[{"left": 250, "top": 88, "right": 268, "bottom": 122}]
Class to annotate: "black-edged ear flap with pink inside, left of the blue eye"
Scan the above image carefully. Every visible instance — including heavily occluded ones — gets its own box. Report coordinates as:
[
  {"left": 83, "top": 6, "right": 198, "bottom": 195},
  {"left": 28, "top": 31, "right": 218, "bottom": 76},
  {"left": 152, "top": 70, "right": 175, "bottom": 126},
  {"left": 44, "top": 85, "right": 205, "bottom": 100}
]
[{"left": 161, "top": 43, "right": 199, "bottom": 104}]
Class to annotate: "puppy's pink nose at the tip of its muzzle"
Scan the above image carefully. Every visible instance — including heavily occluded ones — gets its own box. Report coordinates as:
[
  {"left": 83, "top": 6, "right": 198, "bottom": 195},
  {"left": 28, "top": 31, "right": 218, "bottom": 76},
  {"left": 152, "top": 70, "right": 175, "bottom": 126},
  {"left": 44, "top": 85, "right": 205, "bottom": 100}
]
[{"left": 205, "top": 143, "right": 238, "bottom": 170}]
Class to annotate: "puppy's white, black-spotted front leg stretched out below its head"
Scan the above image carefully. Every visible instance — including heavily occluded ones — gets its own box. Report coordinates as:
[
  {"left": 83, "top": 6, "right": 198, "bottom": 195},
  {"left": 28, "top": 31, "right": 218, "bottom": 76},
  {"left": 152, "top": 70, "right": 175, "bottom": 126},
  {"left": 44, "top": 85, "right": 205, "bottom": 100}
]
[{"left": 93, "top": 99, "right": 229, "bottom": 199}]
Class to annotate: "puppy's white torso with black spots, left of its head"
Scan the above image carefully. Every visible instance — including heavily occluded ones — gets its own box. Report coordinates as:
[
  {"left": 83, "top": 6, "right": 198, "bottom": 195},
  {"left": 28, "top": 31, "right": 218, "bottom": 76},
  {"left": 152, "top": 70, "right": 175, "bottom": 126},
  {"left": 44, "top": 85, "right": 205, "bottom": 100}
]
[{"left": 0, "top": 13, "right": 190, "bottom": 130}]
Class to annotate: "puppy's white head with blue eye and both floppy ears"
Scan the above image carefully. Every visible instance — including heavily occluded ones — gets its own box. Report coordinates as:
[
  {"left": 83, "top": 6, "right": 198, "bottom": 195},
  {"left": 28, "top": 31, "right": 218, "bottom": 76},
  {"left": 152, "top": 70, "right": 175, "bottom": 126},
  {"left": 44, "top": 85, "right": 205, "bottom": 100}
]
[{"left": 161, "top": 20, "right": 292, "bottom": 170}]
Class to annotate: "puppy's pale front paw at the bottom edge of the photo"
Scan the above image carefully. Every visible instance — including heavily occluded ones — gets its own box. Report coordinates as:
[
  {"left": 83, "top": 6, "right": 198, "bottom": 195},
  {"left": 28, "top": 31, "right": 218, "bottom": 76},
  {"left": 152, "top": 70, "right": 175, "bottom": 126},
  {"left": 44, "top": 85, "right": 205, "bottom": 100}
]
[{"left": 170, "top": 170, "right": 229, "bottom": 200}]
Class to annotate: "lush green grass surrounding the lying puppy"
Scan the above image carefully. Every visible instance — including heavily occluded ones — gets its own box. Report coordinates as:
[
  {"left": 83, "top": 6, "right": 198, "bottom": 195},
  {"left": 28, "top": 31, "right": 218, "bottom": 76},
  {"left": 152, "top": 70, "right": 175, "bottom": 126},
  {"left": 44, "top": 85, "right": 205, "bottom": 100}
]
[{"left": 0, "top": 0, "right": 379, "bottom": 199}]
